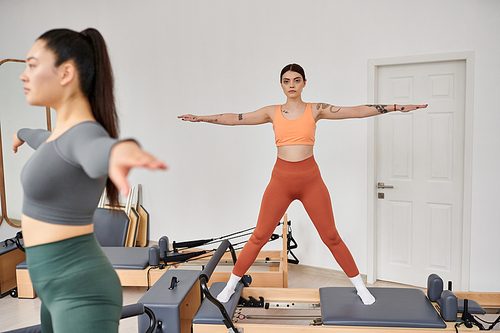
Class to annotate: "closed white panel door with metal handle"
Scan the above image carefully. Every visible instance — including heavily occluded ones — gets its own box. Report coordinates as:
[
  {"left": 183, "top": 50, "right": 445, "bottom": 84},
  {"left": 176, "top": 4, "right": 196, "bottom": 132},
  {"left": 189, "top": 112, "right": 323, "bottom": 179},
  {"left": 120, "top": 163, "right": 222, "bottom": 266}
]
[{"left": 376, "top": 61, "right": 465, "bottom": 287}]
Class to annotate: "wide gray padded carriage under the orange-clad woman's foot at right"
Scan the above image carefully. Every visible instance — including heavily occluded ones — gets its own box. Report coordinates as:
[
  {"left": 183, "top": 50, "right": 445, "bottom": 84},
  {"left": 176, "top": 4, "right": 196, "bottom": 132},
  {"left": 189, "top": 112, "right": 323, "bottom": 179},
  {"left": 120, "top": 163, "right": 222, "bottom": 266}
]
[{"left": 319, "top": 287, "right": 446, "bottom": 328}]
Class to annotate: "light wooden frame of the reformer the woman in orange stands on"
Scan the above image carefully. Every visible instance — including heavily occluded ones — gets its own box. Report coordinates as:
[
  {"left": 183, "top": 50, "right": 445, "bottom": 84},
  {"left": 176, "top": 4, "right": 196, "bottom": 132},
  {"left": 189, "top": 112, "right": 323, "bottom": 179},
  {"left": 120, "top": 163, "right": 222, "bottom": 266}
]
[{"left": 192, "top": 287, "right": 500, "bottom": 333}]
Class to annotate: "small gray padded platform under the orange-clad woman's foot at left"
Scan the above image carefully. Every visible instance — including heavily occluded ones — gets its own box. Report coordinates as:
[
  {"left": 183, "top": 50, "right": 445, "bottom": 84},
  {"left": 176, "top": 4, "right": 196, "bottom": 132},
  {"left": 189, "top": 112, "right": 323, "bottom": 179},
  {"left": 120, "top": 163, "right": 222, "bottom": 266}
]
[{"left": 193, "top": 282, "right": 243, "bottom": 325}]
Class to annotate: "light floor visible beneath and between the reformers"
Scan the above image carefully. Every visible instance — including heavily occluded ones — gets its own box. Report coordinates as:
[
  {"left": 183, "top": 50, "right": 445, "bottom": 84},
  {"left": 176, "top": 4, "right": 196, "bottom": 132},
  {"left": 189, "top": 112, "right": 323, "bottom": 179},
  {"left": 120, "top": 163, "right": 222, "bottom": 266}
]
[{"left": 0, "top": 265, "right": 500, "bottom": 333}]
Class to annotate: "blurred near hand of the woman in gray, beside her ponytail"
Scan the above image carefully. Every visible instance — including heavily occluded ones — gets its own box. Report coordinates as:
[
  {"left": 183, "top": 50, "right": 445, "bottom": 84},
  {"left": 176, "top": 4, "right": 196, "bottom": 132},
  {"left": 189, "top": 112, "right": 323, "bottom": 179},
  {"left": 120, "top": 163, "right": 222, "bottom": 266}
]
[{"left": 108, "top": 141, "right": 167, "bottom": 196}]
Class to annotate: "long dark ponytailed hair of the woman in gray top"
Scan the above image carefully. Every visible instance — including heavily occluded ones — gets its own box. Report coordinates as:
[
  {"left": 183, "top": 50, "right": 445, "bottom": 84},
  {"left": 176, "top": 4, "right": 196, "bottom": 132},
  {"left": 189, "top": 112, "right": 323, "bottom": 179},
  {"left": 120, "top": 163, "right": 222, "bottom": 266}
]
[{"left": 38, "top": 28, "right": 119, "bottom": 206}]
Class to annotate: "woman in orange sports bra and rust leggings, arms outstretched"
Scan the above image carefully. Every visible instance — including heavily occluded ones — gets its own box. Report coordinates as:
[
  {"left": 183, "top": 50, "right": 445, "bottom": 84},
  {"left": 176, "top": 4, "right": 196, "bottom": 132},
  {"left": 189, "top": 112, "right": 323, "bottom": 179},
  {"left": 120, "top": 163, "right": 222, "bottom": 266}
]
[{"left": 178, "top": 64, "right": 427, "bottom": 305}]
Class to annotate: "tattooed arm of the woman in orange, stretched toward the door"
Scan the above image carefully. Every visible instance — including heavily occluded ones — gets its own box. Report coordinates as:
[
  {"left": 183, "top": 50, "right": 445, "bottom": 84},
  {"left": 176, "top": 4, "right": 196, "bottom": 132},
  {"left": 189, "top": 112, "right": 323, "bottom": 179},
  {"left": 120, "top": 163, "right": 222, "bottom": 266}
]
[{"left": 313, "top": 103, "right": 428, "bottom": 120}]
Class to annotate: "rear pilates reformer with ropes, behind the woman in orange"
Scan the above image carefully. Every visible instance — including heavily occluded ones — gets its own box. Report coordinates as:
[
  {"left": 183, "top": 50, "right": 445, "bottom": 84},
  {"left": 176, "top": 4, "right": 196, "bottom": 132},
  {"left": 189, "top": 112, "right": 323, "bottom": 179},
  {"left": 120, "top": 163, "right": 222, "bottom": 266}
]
[{"left": 16, "top": 213, "right": 298, "bottom": 298}]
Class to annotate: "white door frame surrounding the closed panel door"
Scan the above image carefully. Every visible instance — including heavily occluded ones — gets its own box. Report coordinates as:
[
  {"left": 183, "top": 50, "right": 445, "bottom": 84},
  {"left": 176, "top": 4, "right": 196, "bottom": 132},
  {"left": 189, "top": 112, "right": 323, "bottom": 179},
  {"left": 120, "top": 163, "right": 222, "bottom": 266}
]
[{"left": 367, "top": 51, "right": 475, "bottom": 291}]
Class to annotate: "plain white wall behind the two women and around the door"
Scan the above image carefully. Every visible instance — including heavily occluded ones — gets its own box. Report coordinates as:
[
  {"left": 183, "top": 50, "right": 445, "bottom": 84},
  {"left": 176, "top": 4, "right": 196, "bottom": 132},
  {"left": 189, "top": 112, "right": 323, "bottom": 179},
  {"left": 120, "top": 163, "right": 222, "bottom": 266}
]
[{"left": 0, "top": 0, "right": 500, "bottom": 291}]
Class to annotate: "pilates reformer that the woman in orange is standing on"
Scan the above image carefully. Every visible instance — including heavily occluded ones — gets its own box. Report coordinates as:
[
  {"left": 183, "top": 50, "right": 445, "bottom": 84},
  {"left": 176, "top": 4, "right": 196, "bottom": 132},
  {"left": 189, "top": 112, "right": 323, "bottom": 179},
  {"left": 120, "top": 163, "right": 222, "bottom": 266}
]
[{"left": 4, "top": 240, "right": 500, "bottom": 333}]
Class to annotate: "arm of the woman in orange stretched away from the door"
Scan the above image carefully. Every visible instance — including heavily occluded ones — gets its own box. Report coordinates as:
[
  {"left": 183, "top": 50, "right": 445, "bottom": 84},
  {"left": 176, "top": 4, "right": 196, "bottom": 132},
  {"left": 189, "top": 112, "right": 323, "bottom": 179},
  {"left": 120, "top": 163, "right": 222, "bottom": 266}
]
[{"left": 177, "top": 106, "right": 274, "bottom": 126}]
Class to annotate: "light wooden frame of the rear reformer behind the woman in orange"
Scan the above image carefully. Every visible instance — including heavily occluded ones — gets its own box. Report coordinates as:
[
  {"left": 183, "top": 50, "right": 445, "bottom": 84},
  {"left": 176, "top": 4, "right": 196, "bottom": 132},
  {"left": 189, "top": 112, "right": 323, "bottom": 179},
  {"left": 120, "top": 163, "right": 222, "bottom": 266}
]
[{"left": 16, "top": 214, "right": 288, "bottom": 298}]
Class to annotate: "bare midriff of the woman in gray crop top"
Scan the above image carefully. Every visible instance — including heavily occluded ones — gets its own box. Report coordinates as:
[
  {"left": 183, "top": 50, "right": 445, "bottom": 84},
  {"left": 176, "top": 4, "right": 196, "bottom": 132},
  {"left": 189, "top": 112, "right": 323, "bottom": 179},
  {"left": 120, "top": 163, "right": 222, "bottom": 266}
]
[{"left": 21, "top": 214, "right": 94, "bottom": 247}]
